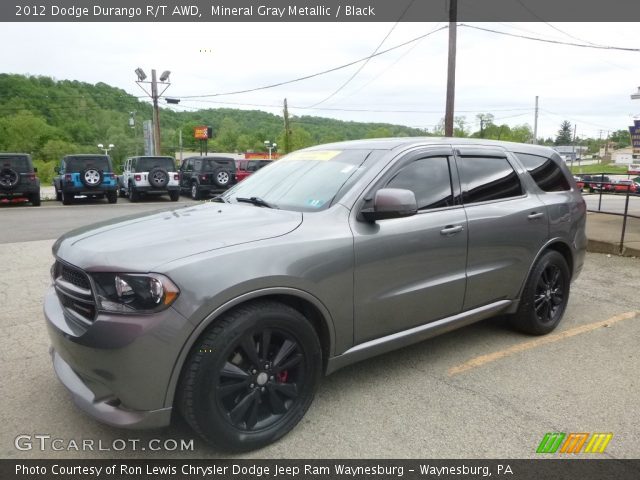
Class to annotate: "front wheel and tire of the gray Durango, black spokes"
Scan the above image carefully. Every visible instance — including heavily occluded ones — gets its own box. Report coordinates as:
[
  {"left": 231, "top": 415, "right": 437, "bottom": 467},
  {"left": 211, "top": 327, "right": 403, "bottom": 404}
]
[{"left": 178, "top": 301, "right": 322, "bottom": 451}]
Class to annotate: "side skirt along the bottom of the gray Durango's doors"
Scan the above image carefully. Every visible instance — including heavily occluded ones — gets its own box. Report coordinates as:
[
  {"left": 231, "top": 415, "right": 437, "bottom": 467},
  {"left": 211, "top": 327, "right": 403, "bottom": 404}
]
[{"left": 326, "top": 300, "right": 513, "bottom": 375}]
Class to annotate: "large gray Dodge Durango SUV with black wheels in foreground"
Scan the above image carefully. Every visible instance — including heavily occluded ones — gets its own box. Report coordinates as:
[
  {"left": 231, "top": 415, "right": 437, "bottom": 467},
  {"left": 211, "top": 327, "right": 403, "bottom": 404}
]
[{"left": 44, "top": 138, "right": 586, "bottom": 450}]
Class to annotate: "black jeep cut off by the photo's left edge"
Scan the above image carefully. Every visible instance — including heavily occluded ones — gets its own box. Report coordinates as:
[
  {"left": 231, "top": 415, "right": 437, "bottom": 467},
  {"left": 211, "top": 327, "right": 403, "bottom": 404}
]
[{"left": 0, "top": 153, "right": 40, "bottom": 207}]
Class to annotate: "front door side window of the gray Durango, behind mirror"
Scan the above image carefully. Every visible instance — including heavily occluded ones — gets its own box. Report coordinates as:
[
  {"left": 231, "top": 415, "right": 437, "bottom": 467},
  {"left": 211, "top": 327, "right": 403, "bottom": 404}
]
[{"left": 386, "top": 157, "right": 453, "bottom": 210}]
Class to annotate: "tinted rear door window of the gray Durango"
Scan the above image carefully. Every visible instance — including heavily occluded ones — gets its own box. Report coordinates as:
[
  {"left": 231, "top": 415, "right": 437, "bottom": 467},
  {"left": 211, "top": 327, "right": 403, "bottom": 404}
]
[{"left": 459, "top": 157, "right": 522, "bottom": 203}]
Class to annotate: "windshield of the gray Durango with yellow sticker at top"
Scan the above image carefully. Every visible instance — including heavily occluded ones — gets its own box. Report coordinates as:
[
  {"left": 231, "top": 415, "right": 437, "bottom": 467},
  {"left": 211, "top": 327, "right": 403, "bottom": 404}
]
[{"left": 222, "top": 150, "right": 370, "bottom": 212}]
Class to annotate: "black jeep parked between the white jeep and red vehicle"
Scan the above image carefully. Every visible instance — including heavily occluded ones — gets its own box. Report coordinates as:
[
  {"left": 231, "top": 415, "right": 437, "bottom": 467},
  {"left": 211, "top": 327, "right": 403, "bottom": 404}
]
[{"left": 180, "top": 157, "right": 236, "bottom": 200}]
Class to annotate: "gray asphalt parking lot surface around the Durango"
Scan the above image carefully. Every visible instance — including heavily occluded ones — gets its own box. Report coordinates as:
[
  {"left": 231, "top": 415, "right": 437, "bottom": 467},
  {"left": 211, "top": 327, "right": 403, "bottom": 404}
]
[{"left": 0, "top": 200, "right": 640, "bottom": 459}]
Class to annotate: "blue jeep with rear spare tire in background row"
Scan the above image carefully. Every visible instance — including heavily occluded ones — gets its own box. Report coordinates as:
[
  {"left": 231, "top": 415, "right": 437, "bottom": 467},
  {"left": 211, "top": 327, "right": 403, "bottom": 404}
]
[{"left": 53, "top": 154, "right": 118, "bottom": 205}]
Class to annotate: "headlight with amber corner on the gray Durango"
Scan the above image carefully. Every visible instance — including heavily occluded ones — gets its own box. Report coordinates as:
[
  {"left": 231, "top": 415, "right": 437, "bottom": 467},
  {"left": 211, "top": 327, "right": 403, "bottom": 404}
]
[{"left": 91, "top": 273, "right": 180, "bottom": 313}]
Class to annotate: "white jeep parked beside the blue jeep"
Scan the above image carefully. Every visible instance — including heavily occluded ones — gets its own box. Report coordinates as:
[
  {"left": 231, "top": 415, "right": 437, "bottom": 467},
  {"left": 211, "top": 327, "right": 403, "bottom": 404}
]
[{"left": 119, "top": 157, "right": 180, "bottom": 202}]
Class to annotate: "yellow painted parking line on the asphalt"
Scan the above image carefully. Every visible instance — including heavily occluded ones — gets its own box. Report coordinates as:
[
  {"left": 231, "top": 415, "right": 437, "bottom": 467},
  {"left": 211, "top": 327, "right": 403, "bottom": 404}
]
[{"left": 447, "top": 312, "right": 640, "bottom": 376}]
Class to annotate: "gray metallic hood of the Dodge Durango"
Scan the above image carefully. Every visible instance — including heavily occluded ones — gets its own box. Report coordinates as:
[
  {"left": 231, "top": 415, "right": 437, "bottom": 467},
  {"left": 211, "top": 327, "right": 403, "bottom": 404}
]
[{"left": 53, "top": 202, "right": 302, "bottom": 272}]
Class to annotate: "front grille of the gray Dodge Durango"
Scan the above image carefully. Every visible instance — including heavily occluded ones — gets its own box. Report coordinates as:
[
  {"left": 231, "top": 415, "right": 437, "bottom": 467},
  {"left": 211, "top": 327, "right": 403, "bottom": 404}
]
[{"left": 53, "top": 262, "right": 96, "bottom": 324}]
